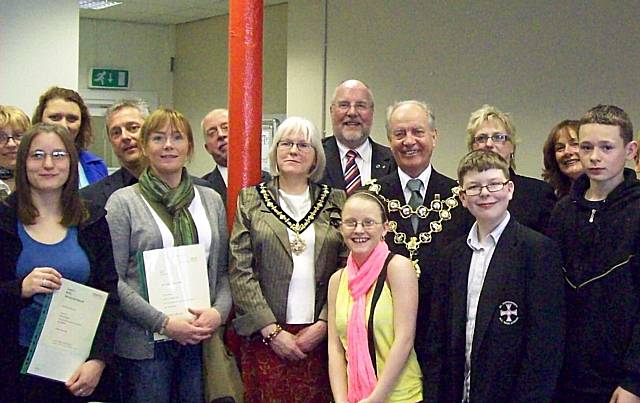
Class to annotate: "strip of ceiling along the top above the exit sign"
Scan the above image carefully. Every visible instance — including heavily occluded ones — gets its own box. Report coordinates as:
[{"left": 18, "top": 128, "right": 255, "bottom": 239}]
[{"left": 80, "top": 0, "right": 287, "bottom": 24}]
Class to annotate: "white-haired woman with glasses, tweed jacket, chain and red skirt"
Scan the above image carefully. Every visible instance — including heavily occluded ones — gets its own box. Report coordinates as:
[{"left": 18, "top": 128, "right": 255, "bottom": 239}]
[{"left": 229, "top": 117, "right": 346, "bottom": 402}]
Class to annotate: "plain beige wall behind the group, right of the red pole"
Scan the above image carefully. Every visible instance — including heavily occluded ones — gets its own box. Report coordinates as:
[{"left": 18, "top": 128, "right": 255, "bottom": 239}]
[{"left": 287, "top": 0, "right": 640, "bottom": 177}]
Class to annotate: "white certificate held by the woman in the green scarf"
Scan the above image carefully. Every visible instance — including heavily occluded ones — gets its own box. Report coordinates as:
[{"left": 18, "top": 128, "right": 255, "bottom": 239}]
[{"left": 142, "top": 244, "right": 211, "bottom": 341}]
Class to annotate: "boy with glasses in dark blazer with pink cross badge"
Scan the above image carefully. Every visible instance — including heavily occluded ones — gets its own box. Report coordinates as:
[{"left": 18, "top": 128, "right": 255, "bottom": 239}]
[{"left": 417, "top": 150, "right": 565, "bottom": 403}]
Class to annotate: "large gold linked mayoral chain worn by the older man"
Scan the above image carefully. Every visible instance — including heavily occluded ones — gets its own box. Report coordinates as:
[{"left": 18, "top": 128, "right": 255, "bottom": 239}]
[{"left": 366, "top": 179, "right": 460, "bottom": 277}]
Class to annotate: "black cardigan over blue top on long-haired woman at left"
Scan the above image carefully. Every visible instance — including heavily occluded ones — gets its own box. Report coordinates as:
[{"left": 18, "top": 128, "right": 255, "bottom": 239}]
[{"left": 0, "top": 193, "right": 119, "bottom": 402}]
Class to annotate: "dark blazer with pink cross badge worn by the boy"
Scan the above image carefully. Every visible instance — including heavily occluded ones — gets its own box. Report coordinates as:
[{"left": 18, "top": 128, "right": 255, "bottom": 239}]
[{"left": 424, "top": 218, "right": 565, "bottom": 403}]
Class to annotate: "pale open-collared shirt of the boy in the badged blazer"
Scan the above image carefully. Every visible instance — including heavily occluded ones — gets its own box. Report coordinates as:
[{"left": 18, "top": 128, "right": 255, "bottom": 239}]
[{"left": 462, "top": 211, "right": 511, "bottom": 402}]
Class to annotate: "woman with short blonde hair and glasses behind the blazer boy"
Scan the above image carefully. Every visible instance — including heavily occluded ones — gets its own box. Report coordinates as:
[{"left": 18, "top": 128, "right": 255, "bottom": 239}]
[{"left": 467, "top": 105, "right": 556, "bottom": 233}]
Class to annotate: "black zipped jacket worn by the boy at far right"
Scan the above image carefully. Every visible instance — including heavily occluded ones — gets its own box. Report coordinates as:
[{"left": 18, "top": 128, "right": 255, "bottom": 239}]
[{"left": 549, "top": 169, "right": 640, "bottom": 396}]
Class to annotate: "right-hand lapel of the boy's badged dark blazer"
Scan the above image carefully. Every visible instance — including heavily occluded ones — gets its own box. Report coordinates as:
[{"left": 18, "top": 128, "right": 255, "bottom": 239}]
[{"left": 472, "top": 217, "right": 517, "bottom": 360}]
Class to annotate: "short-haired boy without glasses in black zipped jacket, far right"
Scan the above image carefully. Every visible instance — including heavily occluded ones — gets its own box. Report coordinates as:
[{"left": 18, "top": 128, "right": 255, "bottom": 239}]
[{"left": 550, "top": 105, "right": 640, "bottom": 403}]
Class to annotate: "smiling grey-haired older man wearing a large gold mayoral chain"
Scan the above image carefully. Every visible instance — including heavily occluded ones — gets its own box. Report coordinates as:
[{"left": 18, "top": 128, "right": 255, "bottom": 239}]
[{"left": 368, "top": 101, "right": 473, "bottom": 356}]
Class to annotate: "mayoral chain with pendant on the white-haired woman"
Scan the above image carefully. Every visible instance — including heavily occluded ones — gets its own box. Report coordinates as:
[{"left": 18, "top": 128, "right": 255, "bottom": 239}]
[{"left": 256, "top": 183, "right": 331, "bottom": 256}]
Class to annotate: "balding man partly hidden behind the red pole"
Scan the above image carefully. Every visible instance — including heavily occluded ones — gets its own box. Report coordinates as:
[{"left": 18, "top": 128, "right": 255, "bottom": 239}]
[{"left": 201, "top": 109, "right": 270, "bottom": 208}]
